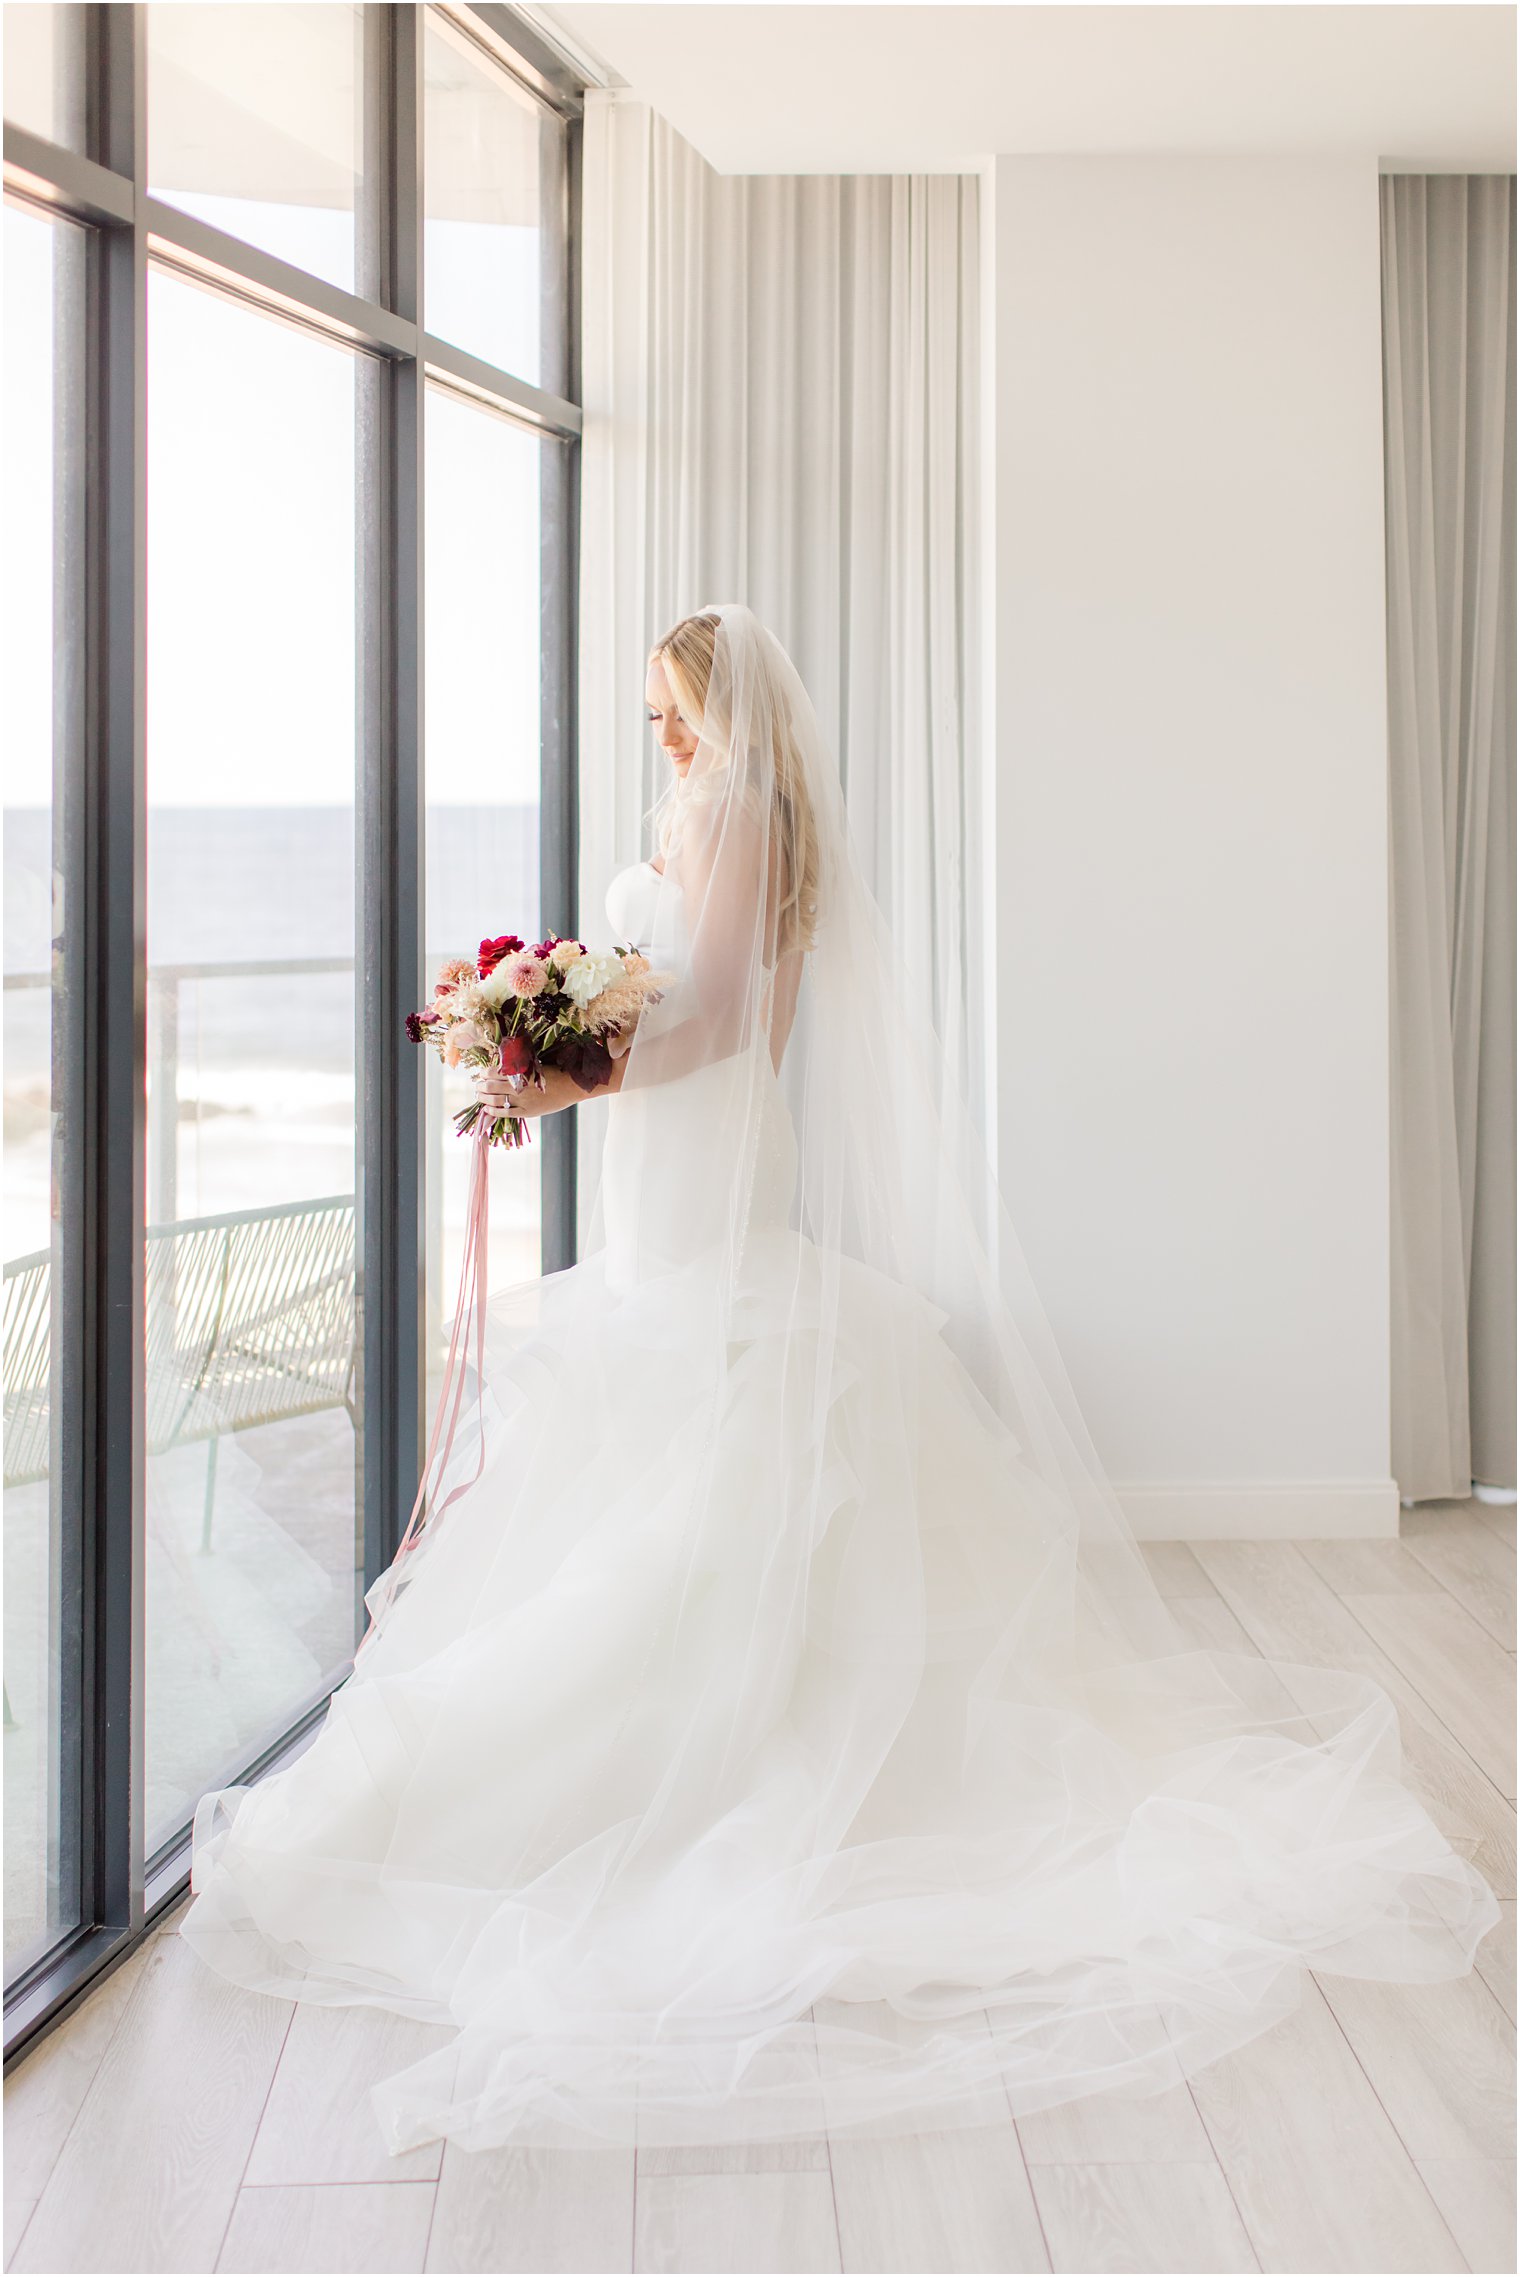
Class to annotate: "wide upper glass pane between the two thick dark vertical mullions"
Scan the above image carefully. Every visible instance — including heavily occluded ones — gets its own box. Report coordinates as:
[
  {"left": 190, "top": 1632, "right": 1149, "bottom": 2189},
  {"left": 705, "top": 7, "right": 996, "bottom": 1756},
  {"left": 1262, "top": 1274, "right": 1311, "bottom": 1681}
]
[{"left": 148, "top": 0, "right": 362, "bottom": 291}]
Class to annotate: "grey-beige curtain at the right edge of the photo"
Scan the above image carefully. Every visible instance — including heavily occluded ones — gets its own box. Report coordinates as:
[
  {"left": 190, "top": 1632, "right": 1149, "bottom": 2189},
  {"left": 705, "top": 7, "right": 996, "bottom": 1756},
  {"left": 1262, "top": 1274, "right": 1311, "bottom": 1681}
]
[{"left": 1381, "top": 175, "right": 1515, "bottom": 1501}]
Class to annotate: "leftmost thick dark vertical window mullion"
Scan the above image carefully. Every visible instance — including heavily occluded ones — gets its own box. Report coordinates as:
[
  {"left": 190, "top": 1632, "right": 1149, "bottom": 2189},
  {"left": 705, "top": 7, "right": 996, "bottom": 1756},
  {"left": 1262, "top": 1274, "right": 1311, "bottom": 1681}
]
[{"left": 91, "top": 5, "right": 148, "bottom": 1933}]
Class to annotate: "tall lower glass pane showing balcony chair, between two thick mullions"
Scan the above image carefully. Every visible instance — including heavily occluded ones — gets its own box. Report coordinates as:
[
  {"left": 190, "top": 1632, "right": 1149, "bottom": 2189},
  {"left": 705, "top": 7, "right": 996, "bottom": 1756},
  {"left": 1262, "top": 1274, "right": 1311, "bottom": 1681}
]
[{"left": 148, "top": 271, "right": 362, "bottom": 1851}]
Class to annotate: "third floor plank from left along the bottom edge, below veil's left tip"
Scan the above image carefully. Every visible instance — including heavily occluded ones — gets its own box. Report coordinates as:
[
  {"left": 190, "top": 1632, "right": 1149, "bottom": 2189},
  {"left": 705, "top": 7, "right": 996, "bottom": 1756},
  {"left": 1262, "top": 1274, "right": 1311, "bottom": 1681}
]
[{"left": 428, "top": 2143, "right": 635, "bottom": 2277}]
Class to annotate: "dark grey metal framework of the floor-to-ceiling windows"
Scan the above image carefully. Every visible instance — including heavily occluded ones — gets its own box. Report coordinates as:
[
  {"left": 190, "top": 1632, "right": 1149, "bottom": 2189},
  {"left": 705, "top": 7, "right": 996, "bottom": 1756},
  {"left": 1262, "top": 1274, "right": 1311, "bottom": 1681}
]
[{"left": 5, "top": 0, "right": 583, "bottom": 2068}]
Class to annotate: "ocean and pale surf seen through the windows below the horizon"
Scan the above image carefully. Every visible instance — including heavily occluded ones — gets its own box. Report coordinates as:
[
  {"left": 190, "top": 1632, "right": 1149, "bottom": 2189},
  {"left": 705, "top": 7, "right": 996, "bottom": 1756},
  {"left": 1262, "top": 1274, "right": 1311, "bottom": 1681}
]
[{"left": 2, "top": 804, "right": 539, "bottom": 1259}]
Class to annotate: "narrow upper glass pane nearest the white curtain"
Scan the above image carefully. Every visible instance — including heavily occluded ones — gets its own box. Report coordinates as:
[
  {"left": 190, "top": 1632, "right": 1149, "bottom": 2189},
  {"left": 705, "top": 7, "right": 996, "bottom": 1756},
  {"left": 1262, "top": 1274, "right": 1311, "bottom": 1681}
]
[{"left": 423, "top": 14, "right": 564, "bottom": 392}]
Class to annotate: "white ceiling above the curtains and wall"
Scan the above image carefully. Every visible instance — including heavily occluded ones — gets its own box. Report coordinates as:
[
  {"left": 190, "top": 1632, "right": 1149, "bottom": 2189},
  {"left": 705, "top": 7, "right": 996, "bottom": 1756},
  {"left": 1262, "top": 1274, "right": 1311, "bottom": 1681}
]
[{"left": 526, "top": 0, "right": 1515, "bottom": 173}]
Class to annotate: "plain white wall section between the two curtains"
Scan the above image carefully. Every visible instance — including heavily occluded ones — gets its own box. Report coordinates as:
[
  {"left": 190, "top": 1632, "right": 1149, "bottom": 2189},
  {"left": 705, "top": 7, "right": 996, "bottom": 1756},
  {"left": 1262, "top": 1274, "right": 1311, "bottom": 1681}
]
[{"left": 985, "top": 157, "right": 1397, "bottom": 1537}]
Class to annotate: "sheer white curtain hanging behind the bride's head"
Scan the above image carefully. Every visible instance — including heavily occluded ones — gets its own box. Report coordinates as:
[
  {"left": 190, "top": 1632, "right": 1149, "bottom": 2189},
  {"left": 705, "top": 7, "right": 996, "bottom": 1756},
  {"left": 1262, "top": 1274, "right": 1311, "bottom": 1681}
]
[{"left": 580, "top": 91, "right": 988, "bottom": 1174}]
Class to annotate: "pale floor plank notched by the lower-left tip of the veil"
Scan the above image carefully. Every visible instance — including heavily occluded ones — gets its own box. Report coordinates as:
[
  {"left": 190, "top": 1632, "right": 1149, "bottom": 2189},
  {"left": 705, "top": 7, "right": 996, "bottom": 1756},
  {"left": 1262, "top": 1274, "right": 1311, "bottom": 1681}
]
[{"left": 243, "top": 2001, "right": 453, "bottom": 2186}]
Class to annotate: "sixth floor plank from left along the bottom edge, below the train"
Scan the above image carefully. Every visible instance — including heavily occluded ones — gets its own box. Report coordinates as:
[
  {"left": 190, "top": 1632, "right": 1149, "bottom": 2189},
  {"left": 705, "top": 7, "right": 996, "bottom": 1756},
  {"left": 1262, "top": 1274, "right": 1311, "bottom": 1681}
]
[{"left": 831, "top": 2118, "right": 1049, "bottom": 2270}]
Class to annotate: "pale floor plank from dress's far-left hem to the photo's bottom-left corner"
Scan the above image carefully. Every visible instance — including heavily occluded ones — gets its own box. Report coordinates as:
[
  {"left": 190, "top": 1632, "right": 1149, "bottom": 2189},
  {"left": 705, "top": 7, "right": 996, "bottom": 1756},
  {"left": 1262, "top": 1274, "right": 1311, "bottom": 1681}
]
[{"left": 16, "top": 1938, "right": 291, "bottom": 2272}]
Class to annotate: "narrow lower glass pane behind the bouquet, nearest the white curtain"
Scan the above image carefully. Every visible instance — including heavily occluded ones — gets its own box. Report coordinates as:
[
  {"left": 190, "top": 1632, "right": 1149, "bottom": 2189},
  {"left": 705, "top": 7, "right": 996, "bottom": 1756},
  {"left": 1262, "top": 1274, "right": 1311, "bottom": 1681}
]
[{"left": 421, "top": 387, "right": 543, "bottom": 1419}]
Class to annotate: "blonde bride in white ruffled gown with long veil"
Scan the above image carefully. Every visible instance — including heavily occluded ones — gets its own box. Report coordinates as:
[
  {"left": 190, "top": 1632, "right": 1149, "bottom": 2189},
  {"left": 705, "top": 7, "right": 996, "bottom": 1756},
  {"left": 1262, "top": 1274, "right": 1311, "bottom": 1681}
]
[{"left": 180, "top": 603, "right": 1500, "bottom": 2152}]
